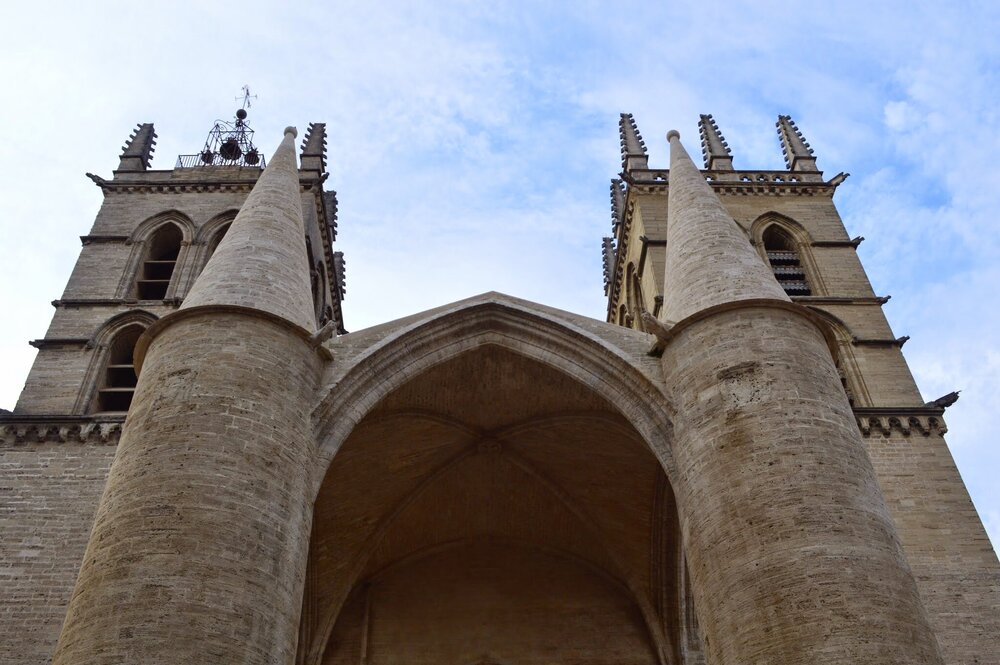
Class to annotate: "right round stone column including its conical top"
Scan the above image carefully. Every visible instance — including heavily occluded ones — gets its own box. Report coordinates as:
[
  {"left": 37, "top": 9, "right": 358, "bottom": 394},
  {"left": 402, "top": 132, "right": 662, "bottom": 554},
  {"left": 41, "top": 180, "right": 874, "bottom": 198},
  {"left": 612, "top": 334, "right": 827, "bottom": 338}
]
[{"left": 663, "top": 132, "right": 941, "bottom": 665}]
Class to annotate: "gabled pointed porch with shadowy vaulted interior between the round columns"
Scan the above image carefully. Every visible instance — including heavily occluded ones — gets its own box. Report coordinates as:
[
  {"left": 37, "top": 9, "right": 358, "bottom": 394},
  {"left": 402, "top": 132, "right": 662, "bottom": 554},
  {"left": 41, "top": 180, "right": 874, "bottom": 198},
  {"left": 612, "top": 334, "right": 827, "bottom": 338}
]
[{"left": 300, "top": 294, "right": 686, "bottom": 665}]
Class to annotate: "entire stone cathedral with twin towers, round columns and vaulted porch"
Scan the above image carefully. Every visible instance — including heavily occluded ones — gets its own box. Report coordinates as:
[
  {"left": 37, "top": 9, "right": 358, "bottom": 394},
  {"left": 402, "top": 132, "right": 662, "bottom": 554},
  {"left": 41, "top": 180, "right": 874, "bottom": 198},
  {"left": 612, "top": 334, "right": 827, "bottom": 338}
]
[{"left": 0, "top": 110, "right": 1000, "bottom": 665}]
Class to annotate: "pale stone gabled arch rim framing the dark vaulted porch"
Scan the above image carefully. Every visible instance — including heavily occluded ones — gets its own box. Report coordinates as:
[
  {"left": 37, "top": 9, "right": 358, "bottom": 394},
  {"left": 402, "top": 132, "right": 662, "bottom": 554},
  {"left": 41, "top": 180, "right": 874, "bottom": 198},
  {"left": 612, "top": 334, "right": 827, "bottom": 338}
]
[{"left": 313, "top": 293, "right": 677, "bottom": 489}]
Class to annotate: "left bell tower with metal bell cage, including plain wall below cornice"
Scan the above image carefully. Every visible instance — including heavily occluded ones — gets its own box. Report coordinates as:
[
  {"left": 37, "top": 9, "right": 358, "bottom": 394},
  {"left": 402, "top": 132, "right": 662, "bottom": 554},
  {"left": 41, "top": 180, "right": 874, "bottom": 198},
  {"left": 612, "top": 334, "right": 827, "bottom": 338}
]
[{"left": 0, "top": 108, "right": 345, "bottom": 662}]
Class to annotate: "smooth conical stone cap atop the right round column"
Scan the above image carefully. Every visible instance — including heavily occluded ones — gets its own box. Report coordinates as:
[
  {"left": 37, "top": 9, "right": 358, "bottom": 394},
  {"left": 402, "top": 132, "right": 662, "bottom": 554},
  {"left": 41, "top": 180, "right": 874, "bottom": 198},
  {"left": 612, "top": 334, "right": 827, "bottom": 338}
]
[{"left": 663, "top": 130, "right": 789, "bottom": 321}]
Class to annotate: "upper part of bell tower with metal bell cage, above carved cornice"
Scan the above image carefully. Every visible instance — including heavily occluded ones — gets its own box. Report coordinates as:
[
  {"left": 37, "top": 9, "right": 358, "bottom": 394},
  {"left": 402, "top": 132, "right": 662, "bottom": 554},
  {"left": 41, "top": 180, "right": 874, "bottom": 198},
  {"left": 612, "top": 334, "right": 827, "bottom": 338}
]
[{"left": 14, "top": 108, "right": 345, "bottom": 420}]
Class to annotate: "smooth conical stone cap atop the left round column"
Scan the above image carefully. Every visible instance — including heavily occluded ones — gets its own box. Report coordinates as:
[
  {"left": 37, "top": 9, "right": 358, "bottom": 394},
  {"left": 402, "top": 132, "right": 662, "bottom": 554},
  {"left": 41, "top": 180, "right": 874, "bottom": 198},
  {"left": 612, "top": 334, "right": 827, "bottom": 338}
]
[{"left": 181, "top": 127, "right": 316, "bottom": 332}]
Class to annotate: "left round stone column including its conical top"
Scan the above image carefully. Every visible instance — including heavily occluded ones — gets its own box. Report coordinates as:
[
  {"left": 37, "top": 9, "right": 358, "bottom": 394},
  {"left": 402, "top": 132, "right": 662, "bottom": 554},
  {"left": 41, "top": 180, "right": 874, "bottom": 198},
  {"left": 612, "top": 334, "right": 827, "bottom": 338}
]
[{"left": 55, "top": 128, "right": 323, "bottom": 665}]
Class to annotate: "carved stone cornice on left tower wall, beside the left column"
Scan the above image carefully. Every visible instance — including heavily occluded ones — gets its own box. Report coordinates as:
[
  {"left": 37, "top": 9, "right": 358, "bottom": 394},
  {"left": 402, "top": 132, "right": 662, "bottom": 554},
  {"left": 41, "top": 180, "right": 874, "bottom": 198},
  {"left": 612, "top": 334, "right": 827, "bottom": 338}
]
[{"left": 0, "top": 413, "right": 125, "bottom": 446}]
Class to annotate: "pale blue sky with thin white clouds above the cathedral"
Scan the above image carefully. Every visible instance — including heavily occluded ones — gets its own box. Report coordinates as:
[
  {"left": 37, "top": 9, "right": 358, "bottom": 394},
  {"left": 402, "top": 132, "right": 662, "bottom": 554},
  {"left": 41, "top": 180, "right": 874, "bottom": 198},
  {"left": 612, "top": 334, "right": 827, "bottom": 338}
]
[{"left": 0, "top": 0, "right": 1000, "bottom": 544}]
